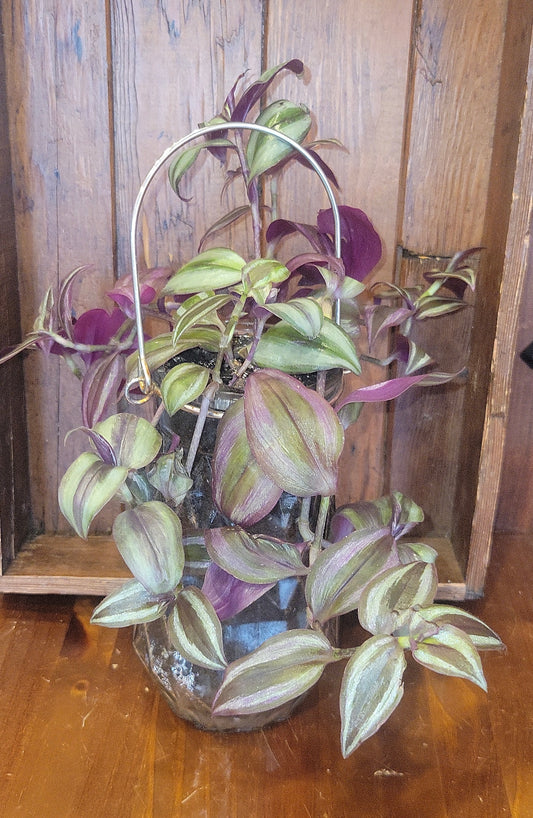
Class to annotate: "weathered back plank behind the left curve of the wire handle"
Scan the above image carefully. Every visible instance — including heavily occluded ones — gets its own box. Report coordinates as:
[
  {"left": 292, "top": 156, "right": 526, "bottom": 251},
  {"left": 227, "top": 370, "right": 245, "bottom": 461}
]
[{"left": 111, "top": 0, "right": 262, "bottom": 284}]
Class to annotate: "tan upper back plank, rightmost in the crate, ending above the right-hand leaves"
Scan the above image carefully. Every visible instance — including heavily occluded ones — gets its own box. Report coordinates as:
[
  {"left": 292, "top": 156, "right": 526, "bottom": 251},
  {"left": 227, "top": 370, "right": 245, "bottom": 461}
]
[{"left": 400, "top": 0, "right": 507, "bottom": 256}]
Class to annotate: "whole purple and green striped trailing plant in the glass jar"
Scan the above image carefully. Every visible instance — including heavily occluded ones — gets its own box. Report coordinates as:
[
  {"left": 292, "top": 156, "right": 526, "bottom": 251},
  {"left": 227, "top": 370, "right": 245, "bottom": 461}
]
[{"left": 5, "top": 60, "right": 501, "bottom": 756}]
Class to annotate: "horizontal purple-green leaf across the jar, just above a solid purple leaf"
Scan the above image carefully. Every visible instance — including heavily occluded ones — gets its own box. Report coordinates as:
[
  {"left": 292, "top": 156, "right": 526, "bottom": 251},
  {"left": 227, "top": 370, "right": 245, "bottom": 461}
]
[{"left": 204, "top": 527, "right": 309, "bottom": 585}]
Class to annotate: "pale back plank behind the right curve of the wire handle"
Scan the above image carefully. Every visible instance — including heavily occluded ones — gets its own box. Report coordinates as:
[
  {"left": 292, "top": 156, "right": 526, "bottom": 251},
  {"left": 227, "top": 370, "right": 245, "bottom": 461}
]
[{"left": 266, "top": 0, "right": 412, "bottom": 502}]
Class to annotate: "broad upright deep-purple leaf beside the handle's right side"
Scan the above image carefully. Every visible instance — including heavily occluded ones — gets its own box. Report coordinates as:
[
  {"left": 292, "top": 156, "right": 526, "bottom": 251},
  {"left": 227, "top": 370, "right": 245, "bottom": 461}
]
[{"left": 317, "top": 205, "right": 381, "bottom": 281}]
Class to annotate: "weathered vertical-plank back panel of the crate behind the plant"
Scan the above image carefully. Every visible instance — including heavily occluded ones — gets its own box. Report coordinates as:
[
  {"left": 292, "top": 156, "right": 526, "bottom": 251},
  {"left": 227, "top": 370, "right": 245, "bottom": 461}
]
[{"left": 2, "top": 0, "right": 533, "bottom": 556}]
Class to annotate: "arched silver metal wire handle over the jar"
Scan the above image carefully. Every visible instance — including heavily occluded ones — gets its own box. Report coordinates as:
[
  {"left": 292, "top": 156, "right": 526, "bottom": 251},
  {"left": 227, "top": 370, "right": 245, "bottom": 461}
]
[{"left": 125, "top": 122, "right": 341, "bottom": 403}]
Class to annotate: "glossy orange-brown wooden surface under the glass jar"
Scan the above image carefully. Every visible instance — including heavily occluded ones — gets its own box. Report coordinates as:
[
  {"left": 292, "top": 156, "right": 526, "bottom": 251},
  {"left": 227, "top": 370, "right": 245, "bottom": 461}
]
[{"left": 0, "top": 535, "right": 533, "bottom": 818}]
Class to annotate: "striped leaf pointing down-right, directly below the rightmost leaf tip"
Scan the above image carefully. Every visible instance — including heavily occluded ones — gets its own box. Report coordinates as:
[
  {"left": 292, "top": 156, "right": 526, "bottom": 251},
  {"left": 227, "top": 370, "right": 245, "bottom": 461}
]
[{"left": 412, "top": 625, "right": 487, "bottom": 691}]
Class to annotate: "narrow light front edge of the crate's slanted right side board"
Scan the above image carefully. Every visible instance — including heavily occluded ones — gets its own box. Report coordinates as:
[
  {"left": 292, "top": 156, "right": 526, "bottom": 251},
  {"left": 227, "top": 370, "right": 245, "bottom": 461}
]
[{"left": 463, "top": 6, "right": 533, "bottom": 594}]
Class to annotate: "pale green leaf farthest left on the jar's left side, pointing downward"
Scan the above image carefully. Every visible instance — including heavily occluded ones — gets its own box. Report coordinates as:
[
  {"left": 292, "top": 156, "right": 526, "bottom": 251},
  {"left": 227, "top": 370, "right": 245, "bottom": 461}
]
[{"left": 58, "top": 452, "right": 128, "bottom": 539}]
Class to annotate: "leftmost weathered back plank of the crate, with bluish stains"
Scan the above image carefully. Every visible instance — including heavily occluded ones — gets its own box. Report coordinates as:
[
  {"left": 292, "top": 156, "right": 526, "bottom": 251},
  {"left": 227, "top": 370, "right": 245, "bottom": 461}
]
[{"left": 2, "top": 0, "right": 113, "bottom": 531}]
